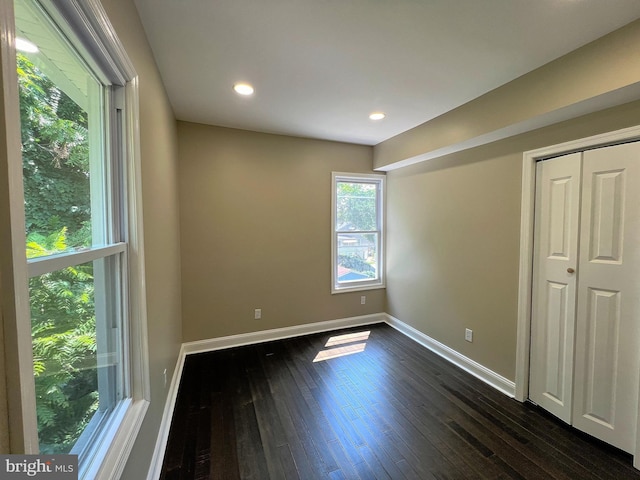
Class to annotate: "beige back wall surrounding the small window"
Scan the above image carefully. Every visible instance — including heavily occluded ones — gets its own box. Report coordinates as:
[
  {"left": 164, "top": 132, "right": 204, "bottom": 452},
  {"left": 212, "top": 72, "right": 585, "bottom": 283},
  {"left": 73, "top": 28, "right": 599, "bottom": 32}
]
[{"left": 178, "top": 122, "right": 384, "bottom": 341}]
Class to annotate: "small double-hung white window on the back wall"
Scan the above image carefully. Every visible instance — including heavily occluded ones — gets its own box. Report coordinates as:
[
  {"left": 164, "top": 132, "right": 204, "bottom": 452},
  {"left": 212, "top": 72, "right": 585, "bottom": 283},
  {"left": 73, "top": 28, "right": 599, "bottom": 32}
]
[{"left": 331, "top": 173, "right": 385, "bottom": 293}]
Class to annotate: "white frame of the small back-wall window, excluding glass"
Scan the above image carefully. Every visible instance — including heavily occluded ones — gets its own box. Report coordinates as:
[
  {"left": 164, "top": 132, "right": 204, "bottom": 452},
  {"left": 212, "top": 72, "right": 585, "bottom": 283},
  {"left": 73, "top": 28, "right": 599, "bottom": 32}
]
[{"left": 331, "top": 172, "right": 386, "bottom": 294}]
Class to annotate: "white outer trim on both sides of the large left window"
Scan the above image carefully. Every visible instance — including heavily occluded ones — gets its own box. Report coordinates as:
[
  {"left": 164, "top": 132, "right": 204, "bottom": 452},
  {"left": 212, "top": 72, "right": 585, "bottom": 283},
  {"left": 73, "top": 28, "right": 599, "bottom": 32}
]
[{"left": 0, "top": 0, "right": 150, "bottom": 479}]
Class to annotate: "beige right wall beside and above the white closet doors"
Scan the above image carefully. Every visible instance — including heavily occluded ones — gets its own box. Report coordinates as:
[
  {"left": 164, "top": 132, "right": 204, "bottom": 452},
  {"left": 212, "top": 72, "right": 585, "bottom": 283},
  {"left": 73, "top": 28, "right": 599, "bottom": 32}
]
[{"left": 387, "top": 102, "right": 640, "bottom": 380}]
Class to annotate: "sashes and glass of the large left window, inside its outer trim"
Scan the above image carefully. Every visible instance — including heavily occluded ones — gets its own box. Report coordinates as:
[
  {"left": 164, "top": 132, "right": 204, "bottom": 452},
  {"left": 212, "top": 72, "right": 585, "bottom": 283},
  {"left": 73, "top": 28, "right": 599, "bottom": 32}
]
[{"left": 14, "top": 0, "right": 132, "bottom": 477}]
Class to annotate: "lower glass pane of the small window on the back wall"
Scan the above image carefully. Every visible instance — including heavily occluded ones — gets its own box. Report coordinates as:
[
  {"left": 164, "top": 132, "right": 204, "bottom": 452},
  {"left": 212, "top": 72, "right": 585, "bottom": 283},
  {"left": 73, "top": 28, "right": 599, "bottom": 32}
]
[{"left": 336, "top": 233, "right": 378, "bottom": 283}]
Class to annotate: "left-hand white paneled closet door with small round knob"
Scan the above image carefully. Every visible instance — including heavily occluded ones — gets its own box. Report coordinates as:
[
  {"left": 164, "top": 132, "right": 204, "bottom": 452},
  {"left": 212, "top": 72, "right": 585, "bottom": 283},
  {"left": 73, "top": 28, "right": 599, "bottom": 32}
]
[{"left": 529, "top": 153, "right": 582, "bottom": 423}]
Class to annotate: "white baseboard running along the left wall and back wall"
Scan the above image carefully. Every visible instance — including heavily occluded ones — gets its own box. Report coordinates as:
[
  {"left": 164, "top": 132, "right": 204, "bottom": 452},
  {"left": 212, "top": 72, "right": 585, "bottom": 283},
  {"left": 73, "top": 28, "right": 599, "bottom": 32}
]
[{"left": 147, "top": 313, "right": 387, "bottom": 480}]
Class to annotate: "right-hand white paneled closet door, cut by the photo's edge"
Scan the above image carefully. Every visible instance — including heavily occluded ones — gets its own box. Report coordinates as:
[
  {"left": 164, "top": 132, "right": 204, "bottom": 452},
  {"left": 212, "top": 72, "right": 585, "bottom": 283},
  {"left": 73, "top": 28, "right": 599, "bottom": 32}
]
[{"left": 573, "top": 143, "right": 640, "bottom": 453}]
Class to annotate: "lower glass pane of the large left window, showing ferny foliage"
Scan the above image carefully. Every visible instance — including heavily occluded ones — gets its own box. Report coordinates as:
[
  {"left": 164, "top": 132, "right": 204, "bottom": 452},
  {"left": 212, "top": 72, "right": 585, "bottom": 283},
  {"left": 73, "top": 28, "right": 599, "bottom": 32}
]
[{"left": 29, "top": 256, "right": 122, "bottom": 454}]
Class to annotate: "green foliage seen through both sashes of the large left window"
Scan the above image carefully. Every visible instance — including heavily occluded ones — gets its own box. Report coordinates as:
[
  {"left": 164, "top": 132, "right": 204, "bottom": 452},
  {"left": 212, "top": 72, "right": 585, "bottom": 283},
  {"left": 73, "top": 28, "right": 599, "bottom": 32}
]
[{"left": 17, "top": 53, "right": 98, "bottom": 453}]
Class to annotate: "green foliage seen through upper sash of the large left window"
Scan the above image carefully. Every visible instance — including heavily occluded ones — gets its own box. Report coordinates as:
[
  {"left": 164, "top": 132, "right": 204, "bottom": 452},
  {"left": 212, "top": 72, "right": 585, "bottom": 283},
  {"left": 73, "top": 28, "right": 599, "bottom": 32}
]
[{"left": 18, "top": 53, "right": 91, "bottom": 251}]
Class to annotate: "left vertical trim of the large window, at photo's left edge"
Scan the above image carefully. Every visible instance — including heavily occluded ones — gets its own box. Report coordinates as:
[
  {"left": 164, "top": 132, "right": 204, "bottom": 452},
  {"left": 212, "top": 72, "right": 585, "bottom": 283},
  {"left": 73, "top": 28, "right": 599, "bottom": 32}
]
[{"left": 0, "top": 0, "right": 38, "bottom": 454}]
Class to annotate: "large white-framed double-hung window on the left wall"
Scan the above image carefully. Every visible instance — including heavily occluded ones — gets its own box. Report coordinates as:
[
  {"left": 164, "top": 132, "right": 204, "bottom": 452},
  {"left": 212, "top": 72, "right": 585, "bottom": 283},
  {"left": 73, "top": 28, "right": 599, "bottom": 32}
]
[{"left": 6, "top": 0, "right": 148, "bottom": 478}]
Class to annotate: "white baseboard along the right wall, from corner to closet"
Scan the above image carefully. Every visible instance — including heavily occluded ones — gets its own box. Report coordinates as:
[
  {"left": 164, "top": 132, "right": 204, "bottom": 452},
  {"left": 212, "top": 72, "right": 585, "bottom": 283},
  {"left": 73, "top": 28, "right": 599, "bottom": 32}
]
[{"left": 385, "top": 314, "right": 516, "bottom": 398}]
